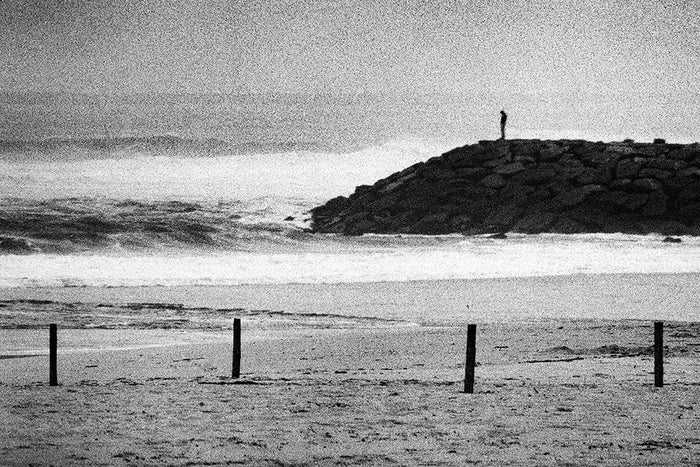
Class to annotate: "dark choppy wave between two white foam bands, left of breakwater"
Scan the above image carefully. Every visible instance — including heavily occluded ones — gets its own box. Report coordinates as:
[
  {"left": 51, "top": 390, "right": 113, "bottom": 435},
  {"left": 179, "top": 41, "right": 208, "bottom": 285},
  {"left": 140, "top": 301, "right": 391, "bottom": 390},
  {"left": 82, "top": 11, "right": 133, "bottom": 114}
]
[{"left": 0, "top": 198, "right": 308, "bottom": 254}]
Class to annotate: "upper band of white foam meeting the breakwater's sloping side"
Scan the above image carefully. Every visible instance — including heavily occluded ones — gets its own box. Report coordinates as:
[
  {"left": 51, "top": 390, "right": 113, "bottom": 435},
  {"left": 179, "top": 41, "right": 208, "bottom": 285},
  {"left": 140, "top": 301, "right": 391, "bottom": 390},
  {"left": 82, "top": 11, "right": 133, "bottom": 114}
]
[{"left": 0, "top": 139, "right": 448, "bottom": 206}]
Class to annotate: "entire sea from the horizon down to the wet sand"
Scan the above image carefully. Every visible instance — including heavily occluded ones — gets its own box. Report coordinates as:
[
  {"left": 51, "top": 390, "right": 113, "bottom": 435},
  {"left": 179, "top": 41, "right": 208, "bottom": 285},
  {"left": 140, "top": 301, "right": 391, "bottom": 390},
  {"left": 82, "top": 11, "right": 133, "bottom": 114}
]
[{"left": 0, "top": 95, "right": 700, "bottom": 288}]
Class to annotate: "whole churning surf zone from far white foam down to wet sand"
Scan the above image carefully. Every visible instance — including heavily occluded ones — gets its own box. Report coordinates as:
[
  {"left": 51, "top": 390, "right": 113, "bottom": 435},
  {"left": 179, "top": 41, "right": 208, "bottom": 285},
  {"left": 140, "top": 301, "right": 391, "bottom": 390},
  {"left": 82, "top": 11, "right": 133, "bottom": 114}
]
[{"left": 0, "top": 135, "right": 700, "bottom": 287}]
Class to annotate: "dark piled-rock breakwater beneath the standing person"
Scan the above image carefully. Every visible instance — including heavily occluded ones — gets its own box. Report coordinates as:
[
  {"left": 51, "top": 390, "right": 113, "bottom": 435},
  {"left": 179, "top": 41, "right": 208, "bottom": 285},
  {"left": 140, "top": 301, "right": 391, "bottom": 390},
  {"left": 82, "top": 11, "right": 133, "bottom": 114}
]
[{"left": 311, "top": 140, "right": 700, "bottom": 235}]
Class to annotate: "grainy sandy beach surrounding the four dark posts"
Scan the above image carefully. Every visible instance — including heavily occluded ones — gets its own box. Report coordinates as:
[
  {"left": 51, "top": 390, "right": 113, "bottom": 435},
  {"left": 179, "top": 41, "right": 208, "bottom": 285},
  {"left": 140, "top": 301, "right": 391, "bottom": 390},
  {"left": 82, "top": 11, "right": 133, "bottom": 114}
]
[{"left": 0, "top": 277, "right": 700, "bottom": 466}]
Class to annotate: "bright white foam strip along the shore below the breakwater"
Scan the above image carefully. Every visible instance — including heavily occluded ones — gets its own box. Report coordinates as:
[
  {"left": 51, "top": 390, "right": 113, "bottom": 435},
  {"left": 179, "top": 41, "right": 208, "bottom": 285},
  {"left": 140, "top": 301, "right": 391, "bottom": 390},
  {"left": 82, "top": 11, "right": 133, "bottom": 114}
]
[{"left": 0, "top": 235, "right": 700, "bottom": 287}]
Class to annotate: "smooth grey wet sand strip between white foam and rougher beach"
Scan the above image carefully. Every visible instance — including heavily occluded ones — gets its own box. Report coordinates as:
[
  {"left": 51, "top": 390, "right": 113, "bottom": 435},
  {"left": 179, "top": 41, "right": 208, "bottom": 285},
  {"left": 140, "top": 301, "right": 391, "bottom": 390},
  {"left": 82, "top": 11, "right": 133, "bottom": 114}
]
[{"left": 0, "top": 273, "right": 700, "bottom": 327}]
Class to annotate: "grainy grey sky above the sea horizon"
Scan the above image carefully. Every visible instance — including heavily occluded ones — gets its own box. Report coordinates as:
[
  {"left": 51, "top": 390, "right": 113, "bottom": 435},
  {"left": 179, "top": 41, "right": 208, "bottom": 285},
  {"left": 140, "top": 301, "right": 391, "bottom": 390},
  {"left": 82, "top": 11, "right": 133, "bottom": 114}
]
[{"left": 0, "top": 0, "right": 700, "bottom": 98}]
